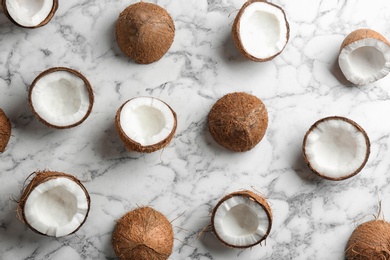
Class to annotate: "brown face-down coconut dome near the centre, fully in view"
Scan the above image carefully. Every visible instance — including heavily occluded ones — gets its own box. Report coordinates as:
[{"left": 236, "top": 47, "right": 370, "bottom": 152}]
[{"left": 208, "top": 92, "right": 268, "bottom": 152}]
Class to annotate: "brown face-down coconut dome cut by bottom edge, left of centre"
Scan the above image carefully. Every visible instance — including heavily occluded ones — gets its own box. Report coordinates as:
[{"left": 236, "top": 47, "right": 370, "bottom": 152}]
[{"left": 112, "top": 207, "right": 173, "bottom": 260}]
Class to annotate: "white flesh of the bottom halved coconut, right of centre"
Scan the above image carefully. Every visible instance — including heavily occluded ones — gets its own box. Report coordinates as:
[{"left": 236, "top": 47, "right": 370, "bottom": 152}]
[{"left": 213, "top": 196, "right": 270, "bottom": 247}]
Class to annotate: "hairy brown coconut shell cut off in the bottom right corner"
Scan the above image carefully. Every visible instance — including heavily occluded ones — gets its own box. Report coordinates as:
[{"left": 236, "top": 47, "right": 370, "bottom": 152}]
[{"left": 346, "top": 220, "right": 390, "bottom": 260}]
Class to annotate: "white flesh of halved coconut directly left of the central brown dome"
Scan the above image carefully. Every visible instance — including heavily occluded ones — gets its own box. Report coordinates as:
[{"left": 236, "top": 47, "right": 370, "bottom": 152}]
[{"left": 120, "top": 97, "right": 175, "bottom": 146}]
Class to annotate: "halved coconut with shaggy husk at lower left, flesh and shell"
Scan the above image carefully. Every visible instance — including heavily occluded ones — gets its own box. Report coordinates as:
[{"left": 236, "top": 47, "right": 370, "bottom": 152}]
[{"left": 18, "top": 171, "right": 90, "bottom": 237}]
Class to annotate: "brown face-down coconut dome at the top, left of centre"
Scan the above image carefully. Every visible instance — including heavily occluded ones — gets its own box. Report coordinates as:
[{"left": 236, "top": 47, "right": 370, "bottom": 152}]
[{"left": 116, "top": 2, "right": 175, "bottom": 64}]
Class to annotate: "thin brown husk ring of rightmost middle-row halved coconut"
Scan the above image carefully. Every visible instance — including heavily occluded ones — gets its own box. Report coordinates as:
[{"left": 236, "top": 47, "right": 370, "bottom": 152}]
[{"left": 302, "top": 116, "right": 371, "bottom": 181}]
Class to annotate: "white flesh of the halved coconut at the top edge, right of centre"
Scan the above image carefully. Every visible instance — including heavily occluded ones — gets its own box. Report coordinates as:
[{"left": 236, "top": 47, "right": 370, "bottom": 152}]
[{"left": 239, "top": 2, "right": 288, "bottom": 59}]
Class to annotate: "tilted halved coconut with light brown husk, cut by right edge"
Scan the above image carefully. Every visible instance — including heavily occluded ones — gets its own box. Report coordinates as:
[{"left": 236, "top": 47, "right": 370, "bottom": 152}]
[{"left": 338, "top": 29, "right": 390, "bottom": 85}]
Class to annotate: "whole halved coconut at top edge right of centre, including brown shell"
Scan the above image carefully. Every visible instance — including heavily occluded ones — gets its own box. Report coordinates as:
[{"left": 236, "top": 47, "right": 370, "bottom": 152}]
[{"left": 232, "top": 0, "right": 290, "bottom": 62}]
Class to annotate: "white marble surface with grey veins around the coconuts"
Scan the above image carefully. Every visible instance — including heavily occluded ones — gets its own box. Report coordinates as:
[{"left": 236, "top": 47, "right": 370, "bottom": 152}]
[{"left": 0, "top": 0, "right": 390, "bottom": 260}]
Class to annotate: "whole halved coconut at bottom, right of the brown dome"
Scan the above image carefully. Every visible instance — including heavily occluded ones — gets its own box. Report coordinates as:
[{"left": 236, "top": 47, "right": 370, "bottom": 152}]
[{"left": 211, "top": 191, "right": 272, "bottom": 248}]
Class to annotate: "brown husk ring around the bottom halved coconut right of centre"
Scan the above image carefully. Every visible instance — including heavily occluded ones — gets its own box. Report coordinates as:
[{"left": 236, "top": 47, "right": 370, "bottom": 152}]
[{"left": 211, "top": 190, "right": 272, "bottom": 248}]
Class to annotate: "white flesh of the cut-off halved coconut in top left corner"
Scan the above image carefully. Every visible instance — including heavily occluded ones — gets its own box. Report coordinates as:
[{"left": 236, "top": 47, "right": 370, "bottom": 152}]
[{"left": 6, "top": 0, "right": 54, "bottom": 27}]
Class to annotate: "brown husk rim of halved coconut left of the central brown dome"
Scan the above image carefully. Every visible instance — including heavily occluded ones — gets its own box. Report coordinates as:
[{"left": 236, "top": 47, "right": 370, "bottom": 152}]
[{"left": 115, "top": 99, "right": 177, "bottom": 153}]
